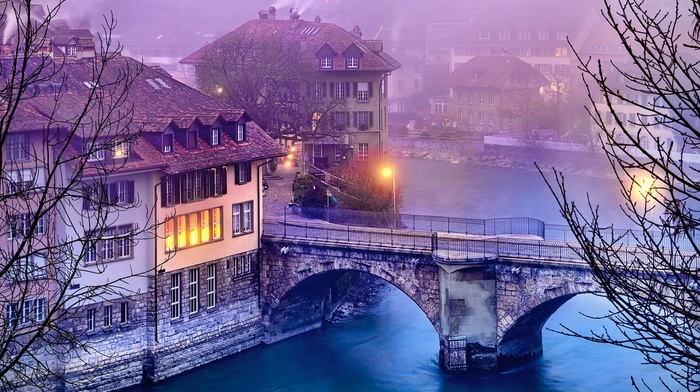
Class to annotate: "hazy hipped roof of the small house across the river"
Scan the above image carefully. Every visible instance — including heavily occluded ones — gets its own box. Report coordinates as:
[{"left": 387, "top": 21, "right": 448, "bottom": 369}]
[{"left": 447, "top": 56, "right": 549, "bottom": 89}]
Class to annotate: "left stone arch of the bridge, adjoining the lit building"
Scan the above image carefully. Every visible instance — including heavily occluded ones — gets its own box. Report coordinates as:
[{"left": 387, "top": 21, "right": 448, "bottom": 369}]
[{"left": 260, "top": 239, "right": 440, "bottom": 343}]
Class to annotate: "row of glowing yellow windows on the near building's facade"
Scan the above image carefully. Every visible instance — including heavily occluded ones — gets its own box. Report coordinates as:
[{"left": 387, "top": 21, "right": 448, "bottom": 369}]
[{"left": 163, "top": 207, "right": 221, "bottom": 252}]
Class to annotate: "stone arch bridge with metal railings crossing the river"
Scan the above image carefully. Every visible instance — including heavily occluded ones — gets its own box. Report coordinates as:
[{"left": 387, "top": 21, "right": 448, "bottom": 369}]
[{"left": 260, "top": 221, "right": 598, "bottom": 372}]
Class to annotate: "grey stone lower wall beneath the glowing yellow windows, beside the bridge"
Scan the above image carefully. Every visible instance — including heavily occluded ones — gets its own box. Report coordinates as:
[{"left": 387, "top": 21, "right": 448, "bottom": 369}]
[{"left": 148, "top": 251, "right": 263, "bottom": 381}]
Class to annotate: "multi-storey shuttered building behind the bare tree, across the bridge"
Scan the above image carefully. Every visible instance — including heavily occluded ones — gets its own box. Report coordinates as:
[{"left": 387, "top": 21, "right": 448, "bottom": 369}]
[{"left": 181, "top": 7, "right": 400, "bottom": 166}]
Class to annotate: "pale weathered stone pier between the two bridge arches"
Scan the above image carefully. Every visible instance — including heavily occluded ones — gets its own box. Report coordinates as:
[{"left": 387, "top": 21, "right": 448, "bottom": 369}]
[{"left": 438, "top": 260, "right": 498, "bottom": 373}]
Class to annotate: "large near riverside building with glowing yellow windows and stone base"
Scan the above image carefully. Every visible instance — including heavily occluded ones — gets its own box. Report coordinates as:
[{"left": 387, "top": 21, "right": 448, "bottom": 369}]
[{"left": 0, "top": 33, "right": 286, "bottom": 390}]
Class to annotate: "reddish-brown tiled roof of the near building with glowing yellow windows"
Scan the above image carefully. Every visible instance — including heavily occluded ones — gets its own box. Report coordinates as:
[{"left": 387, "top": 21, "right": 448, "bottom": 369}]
[{"left": 0, "top": 57, "right": 285, "bottom": 172}]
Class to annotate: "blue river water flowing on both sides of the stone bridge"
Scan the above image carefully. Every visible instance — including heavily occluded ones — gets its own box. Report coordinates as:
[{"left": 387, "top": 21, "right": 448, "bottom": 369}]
[{"left": 133, "top": 158, "right": 676, "bottom": 392}]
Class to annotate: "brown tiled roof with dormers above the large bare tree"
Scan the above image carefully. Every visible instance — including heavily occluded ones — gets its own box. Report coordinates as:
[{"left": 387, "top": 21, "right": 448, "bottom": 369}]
[{"left": 180, "top": 19, "right": 401, "bottom": 72}]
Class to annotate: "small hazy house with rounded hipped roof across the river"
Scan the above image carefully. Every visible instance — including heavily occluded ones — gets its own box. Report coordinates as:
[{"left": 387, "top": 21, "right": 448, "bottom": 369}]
[{"left": 447, "top": 56, "right": 549, "bottom": 133}]
